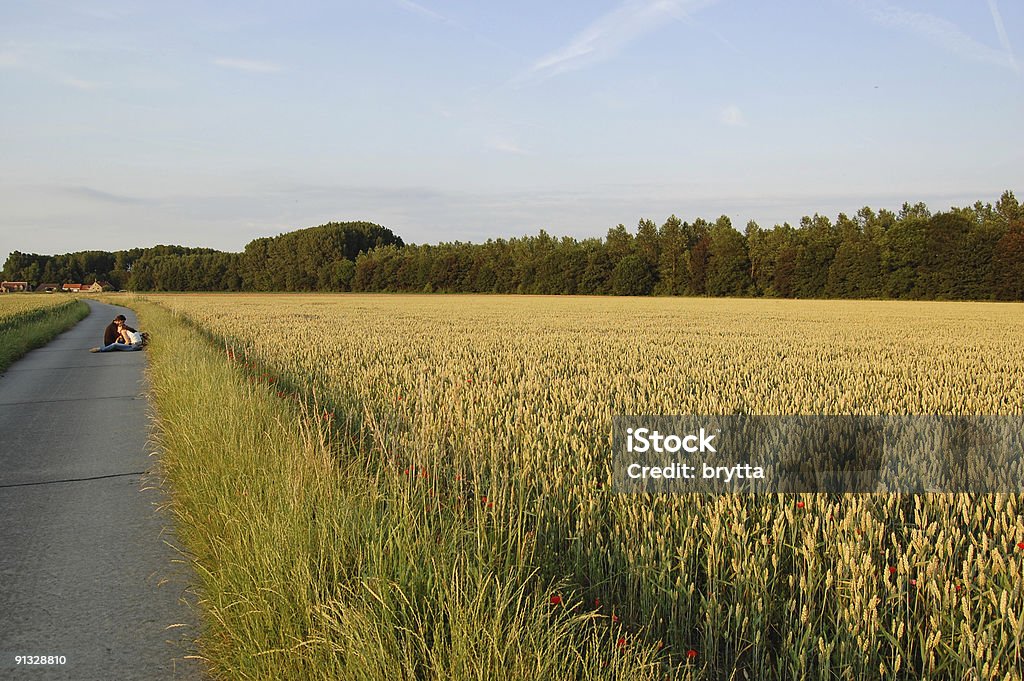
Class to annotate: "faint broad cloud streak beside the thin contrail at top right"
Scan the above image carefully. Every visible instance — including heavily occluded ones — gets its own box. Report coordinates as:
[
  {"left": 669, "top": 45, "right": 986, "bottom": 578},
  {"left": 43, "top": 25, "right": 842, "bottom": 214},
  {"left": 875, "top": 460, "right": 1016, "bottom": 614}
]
[{"left": 854, "top": 0, "right": 1017, "bottom": 71}]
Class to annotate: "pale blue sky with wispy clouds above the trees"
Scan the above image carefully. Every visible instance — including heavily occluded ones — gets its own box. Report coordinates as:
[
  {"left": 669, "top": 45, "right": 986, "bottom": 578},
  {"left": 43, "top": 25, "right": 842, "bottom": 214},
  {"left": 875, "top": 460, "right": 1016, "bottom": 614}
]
[{"left": 0, "top": 0, "right": 1024, "bottom": 257}]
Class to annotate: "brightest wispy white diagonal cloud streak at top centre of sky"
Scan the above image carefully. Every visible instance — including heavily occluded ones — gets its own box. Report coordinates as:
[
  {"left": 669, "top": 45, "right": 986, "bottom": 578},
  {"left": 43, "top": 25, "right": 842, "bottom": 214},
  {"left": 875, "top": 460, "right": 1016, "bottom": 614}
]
[{"left": 520, "top": 0, "right": 715, "bottom": 80}]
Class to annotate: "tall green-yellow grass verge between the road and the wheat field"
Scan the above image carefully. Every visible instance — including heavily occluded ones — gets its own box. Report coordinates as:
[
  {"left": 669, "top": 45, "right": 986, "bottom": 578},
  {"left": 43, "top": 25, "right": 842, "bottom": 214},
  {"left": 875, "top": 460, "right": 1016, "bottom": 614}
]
[{"left": 132, "top": 301, "right": 664, "bottom": 680}]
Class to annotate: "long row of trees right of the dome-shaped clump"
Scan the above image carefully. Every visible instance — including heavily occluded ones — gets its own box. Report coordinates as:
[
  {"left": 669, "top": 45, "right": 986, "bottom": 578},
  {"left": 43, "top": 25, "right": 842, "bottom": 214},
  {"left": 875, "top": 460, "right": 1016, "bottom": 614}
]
[{"left": 352, "top": 191, "right": 1024, "bottom": 300}]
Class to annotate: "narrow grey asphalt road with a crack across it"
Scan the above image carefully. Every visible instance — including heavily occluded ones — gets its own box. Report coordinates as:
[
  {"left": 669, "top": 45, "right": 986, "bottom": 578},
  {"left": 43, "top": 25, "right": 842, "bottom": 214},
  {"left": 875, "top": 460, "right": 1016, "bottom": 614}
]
[{"left": 0, "top": 300, "right": 201, "bottom": 681}]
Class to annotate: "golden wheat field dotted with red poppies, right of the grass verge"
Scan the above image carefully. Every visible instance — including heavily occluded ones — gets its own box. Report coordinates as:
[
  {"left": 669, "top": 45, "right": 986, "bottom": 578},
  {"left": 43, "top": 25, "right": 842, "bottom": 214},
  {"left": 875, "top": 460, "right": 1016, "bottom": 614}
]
[{"left": 150, "top": 295, "right": 1024, "bottom": 679}]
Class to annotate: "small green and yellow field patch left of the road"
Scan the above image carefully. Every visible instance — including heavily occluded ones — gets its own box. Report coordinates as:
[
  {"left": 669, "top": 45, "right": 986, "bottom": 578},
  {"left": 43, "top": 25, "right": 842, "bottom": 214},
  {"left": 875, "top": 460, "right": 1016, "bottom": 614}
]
[{"left": 0, "top": 294, "right": 89, "bottom": 372}]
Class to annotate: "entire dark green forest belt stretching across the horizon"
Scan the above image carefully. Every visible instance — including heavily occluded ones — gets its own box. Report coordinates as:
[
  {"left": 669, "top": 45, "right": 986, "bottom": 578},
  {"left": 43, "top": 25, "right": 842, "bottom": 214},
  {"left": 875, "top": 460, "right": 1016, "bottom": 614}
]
[{"left": 3, "top": 191, "right": 1024, "bottom": 300}]
